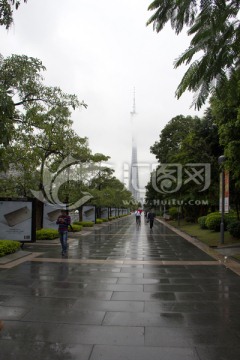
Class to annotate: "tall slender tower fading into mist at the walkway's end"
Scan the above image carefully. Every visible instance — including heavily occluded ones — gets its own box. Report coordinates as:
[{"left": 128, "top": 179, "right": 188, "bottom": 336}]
[{"left": 129, "top": 89, "right": 140, "bottom": 201}]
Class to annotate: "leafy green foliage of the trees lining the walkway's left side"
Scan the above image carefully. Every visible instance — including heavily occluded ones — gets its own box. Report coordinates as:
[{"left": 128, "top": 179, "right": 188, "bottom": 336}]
[{"left": 0, "top": 55, "right": 131, "bottom": 210}]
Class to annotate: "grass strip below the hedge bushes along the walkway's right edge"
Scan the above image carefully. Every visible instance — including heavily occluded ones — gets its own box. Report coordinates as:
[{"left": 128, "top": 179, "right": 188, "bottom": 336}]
[{"left": 168, "top": 220, "right": 240, "bottom": 246}]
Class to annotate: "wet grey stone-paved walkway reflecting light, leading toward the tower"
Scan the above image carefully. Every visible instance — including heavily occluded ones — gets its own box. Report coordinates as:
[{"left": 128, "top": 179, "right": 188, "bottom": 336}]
[{"left": 0, "top": 216, "right": 240, "bottom": 360}]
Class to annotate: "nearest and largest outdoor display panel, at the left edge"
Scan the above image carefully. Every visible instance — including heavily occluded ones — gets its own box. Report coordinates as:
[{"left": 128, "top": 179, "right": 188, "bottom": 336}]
[{"left": 0, "top": 199, "right": 36, "bottom": 242}]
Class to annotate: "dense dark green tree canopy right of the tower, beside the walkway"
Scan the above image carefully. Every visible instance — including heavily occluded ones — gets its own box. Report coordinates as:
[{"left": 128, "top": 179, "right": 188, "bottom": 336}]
[{"left": 146, "top": 109, "right": 223, "bottom": 218}]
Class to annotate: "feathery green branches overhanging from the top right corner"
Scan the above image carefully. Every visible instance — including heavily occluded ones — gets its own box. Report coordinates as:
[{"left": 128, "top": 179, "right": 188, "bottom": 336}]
[{"left": 147, "top": 0, "right": 240, "bottom": 109}]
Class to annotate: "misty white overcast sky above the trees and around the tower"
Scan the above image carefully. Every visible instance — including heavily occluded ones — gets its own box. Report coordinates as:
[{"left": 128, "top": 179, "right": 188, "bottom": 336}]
[{"left": 0, "top": 0, "right": 204, "bottom": 195}]
